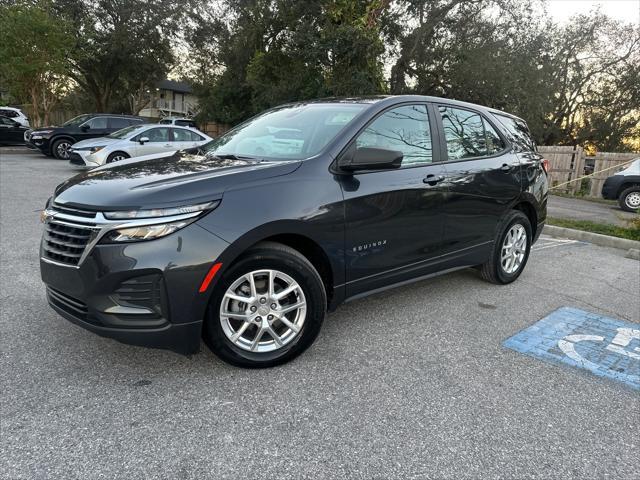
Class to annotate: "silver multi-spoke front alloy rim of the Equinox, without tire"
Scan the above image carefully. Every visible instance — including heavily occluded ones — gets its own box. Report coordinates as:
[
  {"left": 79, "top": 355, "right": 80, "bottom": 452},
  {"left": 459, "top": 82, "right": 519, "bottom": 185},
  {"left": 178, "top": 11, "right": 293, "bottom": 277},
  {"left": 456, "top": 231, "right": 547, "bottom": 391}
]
[{"left": 220, "top": 270, "right": 307, "bottom": 353}]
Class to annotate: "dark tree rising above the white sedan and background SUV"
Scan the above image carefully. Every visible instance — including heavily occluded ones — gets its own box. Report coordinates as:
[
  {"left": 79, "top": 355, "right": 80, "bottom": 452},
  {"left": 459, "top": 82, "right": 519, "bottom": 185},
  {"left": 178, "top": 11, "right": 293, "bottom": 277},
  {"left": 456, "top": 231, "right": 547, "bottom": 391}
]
[{"left": 54, "top": 0, "right": 190, "bottom": 113}]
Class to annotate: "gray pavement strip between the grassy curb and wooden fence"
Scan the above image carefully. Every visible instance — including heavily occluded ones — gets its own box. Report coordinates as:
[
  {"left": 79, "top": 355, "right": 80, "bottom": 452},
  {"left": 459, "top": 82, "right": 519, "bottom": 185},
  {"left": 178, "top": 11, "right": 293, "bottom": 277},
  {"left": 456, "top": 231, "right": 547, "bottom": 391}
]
[{"left": 547, "top": 195, "right": 637, "bottom": 227}]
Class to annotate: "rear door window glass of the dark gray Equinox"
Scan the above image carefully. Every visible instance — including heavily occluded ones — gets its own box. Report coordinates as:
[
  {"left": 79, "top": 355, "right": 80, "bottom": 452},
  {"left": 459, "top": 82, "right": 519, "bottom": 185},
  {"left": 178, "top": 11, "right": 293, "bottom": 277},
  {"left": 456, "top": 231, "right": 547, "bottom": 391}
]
[{"left": 438, "top": 106, "right": 505, "bottom": 160}]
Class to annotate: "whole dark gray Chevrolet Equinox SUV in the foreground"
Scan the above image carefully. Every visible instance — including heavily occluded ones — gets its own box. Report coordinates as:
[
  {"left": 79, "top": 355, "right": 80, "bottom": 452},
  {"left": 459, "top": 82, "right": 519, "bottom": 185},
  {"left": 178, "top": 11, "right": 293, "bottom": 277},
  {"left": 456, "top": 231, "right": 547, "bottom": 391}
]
[{"left": 40, "top": 96, "right": 548, "bottom": 367}]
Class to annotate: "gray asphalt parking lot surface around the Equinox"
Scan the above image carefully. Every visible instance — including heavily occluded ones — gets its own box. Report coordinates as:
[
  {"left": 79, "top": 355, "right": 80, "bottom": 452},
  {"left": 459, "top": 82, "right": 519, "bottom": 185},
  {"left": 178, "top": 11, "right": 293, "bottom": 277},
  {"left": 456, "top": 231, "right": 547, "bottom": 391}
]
[{"left": 0, "top": 149, "right": 640, "bottom": 479}]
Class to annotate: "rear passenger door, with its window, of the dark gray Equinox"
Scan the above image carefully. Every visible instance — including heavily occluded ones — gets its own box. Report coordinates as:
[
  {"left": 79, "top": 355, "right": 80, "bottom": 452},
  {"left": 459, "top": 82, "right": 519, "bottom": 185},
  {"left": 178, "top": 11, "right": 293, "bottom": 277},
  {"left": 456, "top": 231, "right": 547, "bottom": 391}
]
[{"left": 435, "top": 104, "right": 521, "bottom": 261}]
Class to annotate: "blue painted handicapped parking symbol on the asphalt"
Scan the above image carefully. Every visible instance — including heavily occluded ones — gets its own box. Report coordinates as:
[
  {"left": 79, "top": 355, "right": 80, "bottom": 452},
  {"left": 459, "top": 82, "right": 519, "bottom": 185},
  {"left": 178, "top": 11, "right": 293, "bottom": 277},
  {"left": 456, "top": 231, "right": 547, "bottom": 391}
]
[{"left": 503, "top": 307, "right": 640, "bottom": 390}]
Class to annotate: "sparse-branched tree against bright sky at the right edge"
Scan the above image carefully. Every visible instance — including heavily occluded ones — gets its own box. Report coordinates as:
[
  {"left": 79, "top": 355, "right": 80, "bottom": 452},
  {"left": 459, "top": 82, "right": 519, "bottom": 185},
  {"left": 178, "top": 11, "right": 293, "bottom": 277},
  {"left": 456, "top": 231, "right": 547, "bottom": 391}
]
[{"left": 543, "top": 11, "right": 640, "bottom": 149}]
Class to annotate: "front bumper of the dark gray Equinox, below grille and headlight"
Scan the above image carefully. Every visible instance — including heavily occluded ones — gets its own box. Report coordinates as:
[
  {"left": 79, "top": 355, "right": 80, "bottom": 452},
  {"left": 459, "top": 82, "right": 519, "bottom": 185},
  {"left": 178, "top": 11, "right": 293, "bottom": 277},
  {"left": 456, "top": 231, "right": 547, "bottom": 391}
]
[{"left": 40, "top": 223, "right": 228, "bottom": 354}]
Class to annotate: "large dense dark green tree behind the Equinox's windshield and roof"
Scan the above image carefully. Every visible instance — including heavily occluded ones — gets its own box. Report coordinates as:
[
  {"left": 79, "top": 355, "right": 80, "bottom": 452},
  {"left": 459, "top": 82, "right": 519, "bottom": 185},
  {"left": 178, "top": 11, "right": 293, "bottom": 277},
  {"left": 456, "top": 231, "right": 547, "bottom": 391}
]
[{"left": 187, "top": 0, "right": 389, "bottom": 123}]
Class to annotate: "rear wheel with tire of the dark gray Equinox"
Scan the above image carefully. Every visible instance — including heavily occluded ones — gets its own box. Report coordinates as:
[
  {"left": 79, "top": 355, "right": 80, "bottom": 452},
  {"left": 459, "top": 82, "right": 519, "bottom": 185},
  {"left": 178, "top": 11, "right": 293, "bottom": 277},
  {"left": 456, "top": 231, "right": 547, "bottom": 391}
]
[{"left": 480, "top": 210, "right": 533, "bottom": 285}]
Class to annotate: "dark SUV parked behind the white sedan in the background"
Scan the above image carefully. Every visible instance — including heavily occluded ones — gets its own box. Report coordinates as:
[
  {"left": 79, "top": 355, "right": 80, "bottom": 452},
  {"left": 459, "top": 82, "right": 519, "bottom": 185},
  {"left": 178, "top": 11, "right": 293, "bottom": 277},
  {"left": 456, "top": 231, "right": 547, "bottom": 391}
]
[{"left": 24, "top": 113, "right": 145, "bottom": 160}]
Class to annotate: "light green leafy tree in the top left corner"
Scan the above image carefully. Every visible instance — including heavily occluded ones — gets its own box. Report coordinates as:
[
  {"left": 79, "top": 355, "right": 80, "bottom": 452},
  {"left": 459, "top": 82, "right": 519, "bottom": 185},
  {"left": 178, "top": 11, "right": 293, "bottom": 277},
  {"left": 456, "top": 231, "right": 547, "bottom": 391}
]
[{"left": 0, "top": 2, "right": 73, "bottom": 125}]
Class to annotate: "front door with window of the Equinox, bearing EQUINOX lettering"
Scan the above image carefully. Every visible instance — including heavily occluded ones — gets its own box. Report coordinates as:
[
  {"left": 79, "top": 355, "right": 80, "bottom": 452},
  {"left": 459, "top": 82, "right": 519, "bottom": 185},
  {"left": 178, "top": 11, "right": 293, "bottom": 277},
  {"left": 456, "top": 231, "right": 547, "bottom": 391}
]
[{"left": 340, "top": 104, "right": 445, "bottom": 297}]
